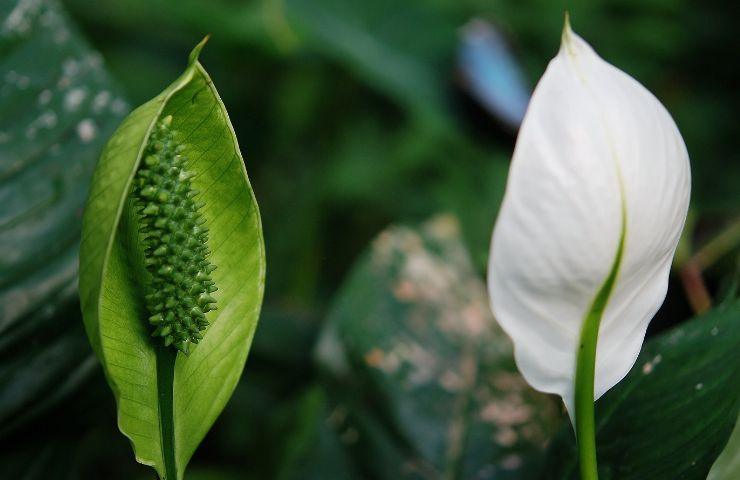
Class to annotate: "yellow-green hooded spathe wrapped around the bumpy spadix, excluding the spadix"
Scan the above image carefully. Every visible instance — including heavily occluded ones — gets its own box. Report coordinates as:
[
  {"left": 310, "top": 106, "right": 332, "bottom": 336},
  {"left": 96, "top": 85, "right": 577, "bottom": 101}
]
[{"left": 80, "top": 41, "right": 265, "bottom": 480}]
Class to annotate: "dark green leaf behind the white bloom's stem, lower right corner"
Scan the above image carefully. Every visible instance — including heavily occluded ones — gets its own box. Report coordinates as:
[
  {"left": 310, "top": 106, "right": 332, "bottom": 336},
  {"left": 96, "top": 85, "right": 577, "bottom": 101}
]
[{"left": 544, "top": 301, "right": 740, "bottom": 480}]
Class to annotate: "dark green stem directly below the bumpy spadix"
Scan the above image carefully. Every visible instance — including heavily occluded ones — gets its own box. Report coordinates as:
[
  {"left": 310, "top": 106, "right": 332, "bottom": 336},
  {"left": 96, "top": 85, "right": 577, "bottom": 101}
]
[{"left": 157, "top": 345, "right": 177, "bottom": 480}]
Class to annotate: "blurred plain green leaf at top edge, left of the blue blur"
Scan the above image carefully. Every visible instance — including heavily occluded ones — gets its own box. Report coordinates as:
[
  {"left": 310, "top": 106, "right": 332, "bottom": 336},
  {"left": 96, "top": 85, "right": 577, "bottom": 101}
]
[{"left": 285, "top": 0, "right": 456, "bottom": 120}]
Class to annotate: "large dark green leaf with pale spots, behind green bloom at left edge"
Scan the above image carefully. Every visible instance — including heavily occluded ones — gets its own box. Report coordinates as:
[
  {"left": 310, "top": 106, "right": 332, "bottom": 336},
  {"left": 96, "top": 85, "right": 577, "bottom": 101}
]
[{"left": 0, "top": 1, "right": 128, "bottom": 432}]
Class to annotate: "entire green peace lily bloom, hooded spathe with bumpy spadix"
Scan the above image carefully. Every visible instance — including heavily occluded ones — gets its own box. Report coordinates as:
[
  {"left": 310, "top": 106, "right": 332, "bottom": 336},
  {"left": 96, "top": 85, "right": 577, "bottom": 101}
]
[{"left": 80, "top": 40, "right": 265, "bottom": 480}]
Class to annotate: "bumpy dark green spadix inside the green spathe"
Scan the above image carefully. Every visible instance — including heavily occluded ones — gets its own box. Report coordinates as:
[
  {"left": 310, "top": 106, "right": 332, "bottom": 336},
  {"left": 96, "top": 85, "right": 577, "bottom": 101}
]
[{"left": 131, "top": 116, "right": 217, "bottom": 354}]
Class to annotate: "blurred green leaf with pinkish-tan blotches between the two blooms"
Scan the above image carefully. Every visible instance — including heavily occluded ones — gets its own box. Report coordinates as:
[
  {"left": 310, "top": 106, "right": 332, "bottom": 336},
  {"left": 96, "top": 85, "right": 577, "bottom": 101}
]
[{"left": 318, "top": 216, "right": 557, "bottom": 479}]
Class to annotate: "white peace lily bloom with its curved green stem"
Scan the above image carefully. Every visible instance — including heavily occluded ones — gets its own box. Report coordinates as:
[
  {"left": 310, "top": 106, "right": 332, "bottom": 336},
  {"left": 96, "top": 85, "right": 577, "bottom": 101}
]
[{"left": 488, "top": 16, "right": 690, "bottom": 480}]
